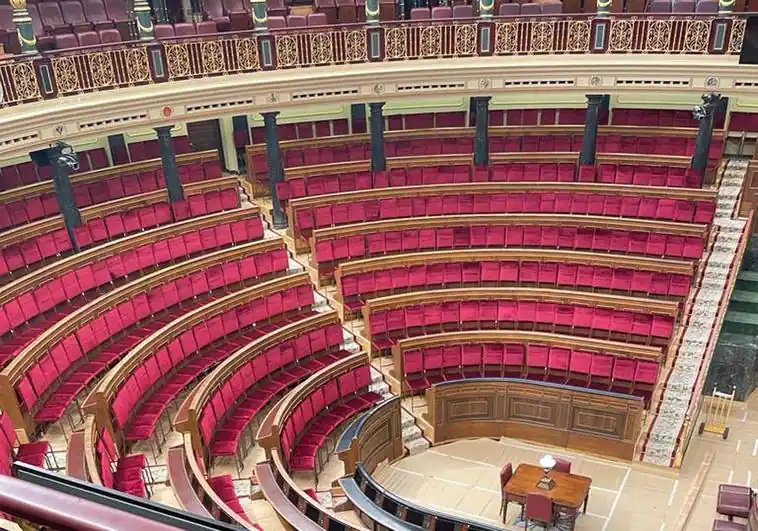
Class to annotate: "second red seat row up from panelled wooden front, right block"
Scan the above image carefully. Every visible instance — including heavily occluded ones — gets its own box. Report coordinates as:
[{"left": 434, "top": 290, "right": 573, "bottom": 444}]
[{"left": 363, "top": 288, "right": 678, "bottom": 352}]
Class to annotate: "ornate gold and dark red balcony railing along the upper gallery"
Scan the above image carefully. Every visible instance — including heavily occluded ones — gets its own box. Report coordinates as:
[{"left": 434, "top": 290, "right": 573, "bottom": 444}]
[{"left": 0, "top": 15, "right": 747, "bottom": 107}]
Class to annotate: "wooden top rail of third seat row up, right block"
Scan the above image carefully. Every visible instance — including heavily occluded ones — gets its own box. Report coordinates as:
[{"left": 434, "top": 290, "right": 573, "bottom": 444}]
[{"left": 334, "top": 249, "right": 695, "bottom": 312}]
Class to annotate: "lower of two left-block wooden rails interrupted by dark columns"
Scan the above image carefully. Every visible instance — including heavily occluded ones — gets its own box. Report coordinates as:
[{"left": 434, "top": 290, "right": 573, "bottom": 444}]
[{"left": 0, "top": 177, "right": 239, "bottom": 249}]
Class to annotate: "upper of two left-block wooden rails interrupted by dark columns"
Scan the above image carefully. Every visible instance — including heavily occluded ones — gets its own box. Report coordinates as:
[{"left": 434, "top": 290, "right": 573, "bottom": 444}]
[{"left": 0, "top": 149, "right": 218, "bottom": 208}]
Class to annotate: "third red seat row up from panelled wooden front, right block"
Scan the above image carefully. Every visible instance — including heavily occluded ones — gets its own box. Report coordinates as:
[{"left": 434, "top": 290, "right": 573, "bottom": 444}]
[{"left": 335, "top": 249, "right": 695, "bottom": 312}]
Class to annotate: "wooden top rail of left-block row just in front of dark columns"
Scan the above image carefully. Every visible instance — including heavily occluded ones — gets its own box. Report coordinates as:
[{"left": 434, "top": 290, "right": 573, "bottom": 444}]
[{"left": 0, "top": 206, "right": 260, "bottom": 304}]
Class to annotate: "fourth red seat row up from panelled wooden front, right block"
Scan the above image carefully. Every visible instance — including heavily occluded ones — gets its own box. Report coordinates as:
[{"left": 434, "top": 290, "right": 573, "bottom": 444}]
[{"left": 310, "top": 214, "right": 709, "bottom": 282}]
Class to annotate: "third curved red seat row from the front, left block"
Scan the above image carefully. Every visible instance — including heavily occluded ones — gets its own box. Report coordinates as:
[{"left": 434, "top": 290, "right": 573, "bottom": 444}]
[{"left": 95, "top": 272, "right": 315, "bottom": 456}]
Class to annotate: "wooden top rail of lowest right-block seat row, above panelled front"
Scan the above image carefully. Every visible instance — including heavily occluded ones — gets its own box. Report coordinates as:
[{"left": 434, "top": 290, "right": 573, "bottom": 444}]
[{"left": 390, "top": 330, "right": 665, "bottom": 395}]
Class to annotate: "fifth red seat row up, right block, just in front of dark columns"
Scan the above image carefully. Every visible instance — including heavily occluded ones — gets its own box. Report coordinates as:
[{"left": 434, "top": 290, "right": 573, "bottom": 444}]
[{"left": 287, "top": 182, "right": 716, "bottom": 250}]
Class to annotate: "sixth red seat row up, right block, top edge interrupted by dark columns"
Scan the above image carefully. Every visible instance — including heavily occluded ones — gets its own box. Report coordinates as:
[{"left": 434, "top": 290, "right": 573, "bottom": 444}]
[{"left": 277, "top": 153, "right": 702, "bottom": 201}]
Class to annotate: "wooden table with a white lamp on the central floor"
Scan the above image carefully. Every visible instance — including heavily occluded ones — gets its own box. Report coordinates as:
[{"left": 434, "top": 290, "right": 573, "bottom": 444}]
[{"left": 503, "top": 463, "right": 592, "bottom": 529}]
